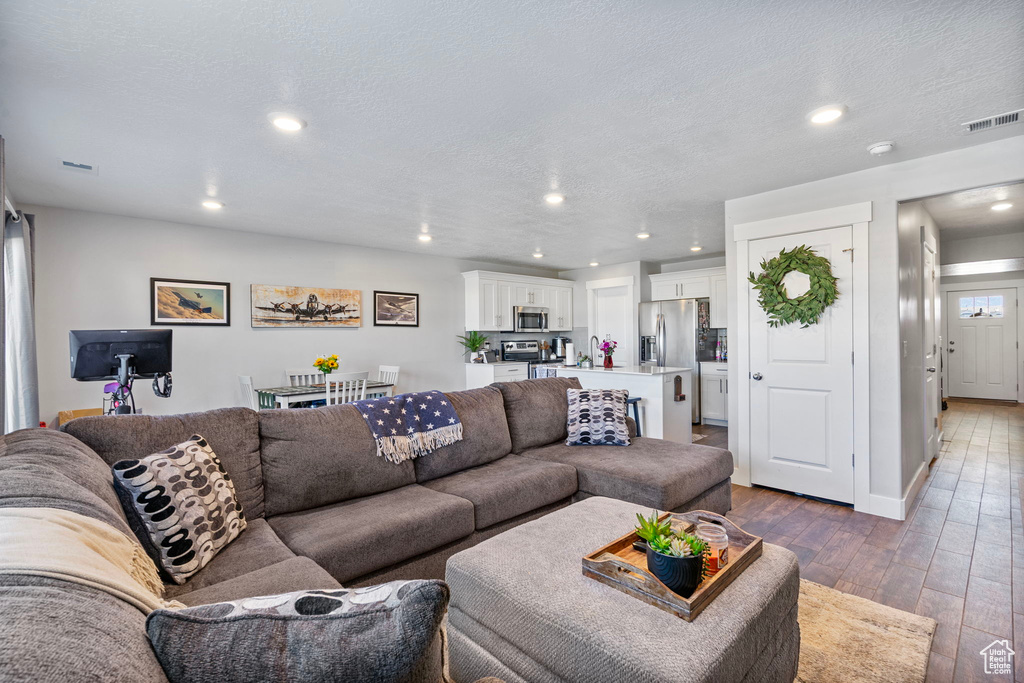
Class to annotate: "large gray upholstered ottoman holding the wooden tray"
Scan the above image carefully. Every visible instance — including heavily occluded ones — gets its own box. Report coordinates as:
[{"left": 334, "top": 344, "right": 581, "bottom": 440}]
[{"left": 445, "top": 498, "right": 800, "bottom": 683}]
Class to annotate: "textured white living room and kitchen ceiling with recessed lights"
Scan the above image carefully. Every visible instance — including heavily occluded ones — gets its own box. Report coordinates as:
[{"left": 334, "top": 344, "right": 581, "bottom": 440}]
[{"left": 0, "top": 0, "right": 1024, "bottom": 269}]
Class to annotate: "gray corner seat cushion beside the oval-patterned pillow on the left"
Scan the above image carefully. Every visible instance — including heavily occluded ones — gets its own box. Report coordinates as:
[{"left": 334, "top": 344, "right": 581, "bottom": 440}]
[{"left": 165, "top": 519, "right": 295, "bottom": 598}]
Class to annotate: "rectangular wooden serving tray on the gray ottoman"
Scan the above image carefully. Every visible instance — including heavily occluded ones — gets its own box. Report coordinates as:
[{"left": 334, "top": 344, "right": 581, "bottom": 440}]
[{"left": 583, "top": 510, "right": 762, "bottom": 622}]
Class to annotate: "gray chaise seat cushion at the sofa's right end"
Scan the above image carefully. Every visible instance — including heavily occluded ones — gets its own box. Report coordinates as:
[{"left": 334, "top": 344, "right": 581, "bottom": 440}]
[{"left": 523, "top": 437, "right": 733, "bottom": 510}]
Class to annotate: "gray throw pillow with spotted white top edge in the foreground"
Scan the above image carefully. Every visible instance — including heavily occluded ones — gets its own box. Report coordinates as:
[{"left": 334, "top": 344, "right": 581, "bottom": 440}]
[{"left": 146, "top": 581, "right": 449, "bottom": 683}]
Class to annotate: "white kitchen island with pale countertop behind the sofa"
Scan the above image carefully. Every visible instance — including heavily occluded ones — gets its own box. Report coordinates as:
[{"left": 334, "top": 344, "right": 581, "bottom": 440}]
[{"left": 555, "top": 366, "right": 692, "bottom": 443}]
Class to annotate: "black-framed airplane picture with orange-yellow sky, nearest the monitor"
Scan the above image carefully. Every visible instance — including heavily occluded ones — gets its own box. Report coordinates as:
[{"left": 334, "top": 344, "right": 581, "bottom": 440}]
[{"left": 150, "top": 278, "right": 231, "bottom": 327}]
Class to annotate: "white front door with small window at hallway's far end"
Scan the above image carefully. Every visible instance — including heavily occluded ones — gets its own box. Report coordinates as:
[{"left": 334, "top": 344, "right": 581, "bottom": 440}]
[{"left": 946, "top": 289, "right": 1017, "bottom": 400}]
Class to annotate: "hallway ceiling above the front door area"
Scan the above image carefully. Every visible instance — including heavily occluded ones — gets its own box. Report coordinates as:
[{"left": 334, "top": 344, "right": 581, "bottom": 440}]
[{"left": 924, "top": 182, "right": 1024, "bottom": 240}]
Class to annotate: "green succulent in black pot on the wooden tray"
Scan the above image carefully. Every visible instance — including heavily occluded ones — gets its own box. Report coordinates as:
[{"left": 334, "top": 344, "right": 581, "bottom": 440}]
[{"left": 636, "top": 512, "right": 708, "bottom": 598}]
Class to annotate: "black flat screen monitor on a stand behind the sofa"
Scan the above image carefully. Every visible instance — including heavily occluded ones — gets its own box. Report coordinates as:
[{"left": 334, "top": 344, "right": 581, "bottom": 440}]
[{"left": 71, "top": 330, "right": 171, "bottom": 382}]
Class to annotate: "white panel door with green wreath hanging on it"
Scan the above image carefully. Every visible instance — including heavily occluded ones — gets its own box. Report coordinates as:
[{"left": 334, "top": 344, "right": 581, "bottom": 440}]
[{"left": 748, "top": 226, "right": 851, "bottom": 503}]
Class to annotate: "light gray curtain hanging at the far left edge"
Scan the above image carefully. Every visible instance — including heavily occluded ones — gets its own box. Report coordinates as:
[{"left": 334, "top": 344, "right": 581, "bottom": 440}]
[{"left": 3, "top": 214, "right": 39, "bottom": 432}]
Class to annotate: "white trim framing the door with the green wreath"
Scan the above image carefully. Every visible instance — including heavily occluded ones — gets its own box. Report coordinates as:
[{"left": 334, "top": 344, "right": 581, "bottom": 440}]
[{"left": 730, "top": 202, "right": 872, "bottom": 511}]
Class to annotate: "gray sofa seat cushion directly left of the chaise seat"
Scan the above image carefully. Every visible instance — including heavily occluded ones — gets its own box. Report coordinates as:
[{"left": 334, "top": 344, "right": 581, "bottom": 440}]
[{"left": 423, "top": 456, "right": 577, "bottom": 529}]
